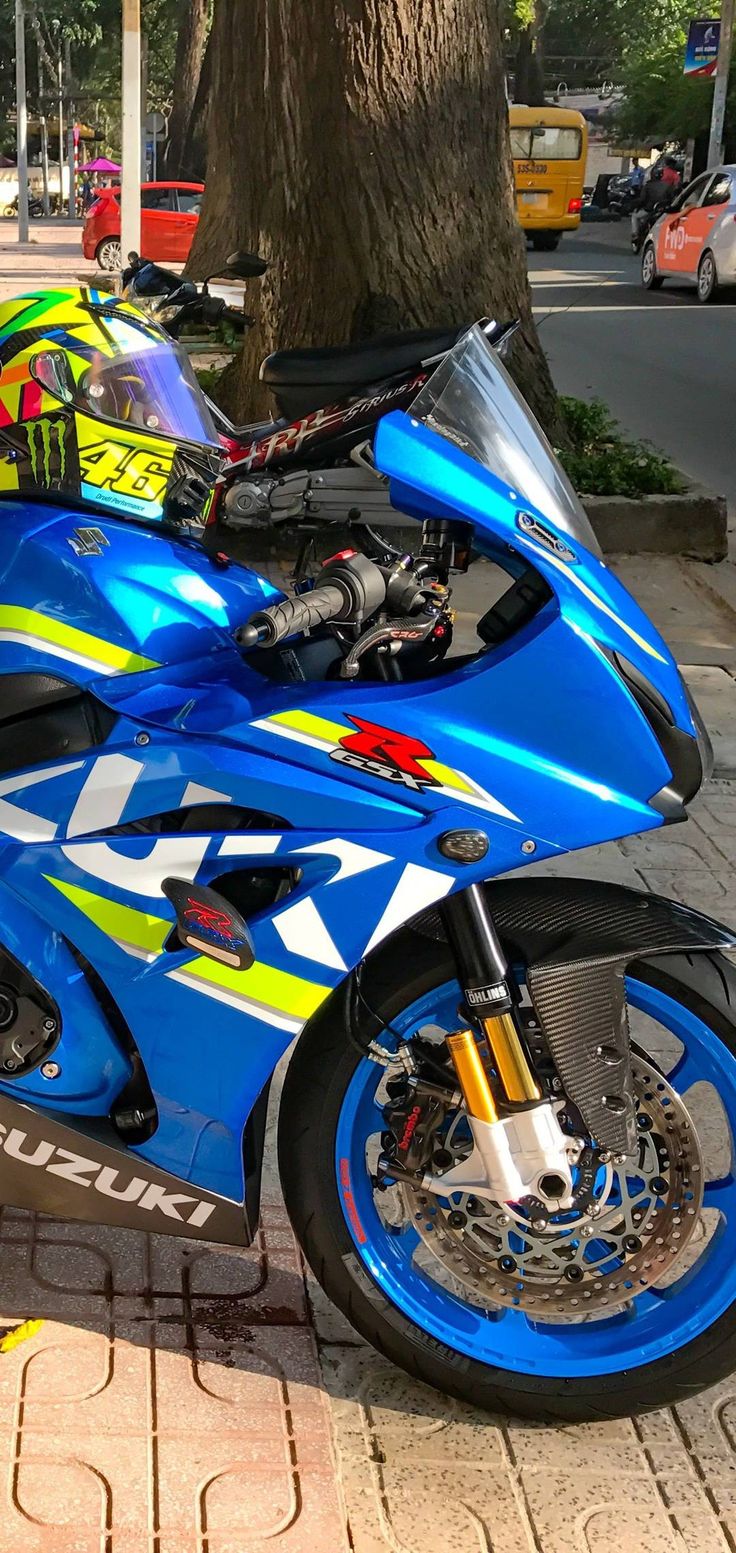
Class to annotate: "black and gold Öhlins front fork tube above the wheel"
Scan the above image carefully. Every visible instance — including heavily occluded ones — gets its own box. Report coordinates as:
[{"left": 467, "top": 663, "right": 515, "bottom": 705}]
[{"left": 443, "top": 884, "right": 542, "bottom": 1121}]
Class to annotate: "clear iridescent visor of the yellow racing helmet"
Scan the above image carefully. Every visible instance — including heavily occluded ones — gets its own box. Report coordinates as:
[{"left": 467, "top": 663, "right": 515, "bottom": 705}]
[{"left": 30, "top": 311, "right": 220, "bottom": 449}]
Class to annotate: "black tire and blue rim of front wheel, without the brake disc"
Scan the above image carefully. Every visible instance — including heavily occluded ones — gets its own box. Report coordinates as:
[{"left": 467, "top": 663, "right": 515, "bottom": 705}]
[{"left": 279, "top": 929, "right": 736, "bottom": 1423}]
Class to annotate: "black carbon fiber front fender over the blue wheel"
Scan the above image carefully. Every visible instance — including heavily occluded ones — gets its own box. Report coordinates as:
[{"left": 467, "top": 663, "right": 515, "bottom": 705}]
[{"left": 415, "top": 877, "right": 736, "bottom": 1152}]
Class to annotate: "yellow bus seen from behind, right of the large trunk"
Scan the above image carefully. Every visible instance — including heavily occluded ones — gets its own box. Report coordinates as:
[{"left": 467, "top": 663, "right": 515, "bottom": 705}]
[{"left": 509, "top": 102, "right": 588, "bottom": 248}]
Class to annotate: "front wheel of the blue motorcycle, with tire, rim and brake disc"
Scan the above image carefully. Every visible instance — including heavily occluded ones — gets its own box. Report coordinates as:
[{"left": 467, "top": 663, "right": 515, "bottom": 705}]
[{"left": 279, "top": 929, "right": 736, "bottom": 1423}]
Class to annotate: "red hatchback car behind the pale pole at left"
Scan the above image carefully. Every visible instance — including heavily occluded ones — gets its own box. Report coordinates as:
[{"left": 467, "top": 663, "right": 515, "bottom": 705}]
[{"left": 82, "top": 183, "right": 205, "bottom": 270}]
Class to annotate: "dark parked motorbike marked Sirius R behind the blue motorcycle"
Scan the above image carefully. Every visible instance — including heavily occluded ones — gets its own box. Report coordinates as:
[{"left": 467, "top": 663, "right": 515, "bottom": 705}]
[{"left": 123, "top": 253, "right": 517, "bottom": 528}]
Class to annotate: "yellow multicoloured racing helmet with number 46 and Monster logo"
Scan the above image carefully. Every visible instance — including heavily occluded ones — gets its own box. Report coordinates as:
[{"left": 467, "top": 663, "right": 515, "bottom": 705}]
[{"left": 0, "top": 287, "right": 224, "bottom": 530}]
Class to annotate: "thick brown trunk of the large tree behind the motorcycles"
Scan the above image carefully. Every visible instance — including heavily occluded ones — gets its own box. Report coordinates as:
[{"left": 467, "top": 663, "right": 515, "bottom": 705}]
[{"left": 189, "top": 0, "right": 559, "bottom": 435}]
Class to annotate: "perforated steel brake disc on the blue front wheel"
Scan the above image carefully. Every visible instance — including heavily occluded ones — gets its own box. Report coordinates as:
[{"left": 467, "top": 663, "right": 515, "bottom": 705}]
[{"left": 401, "top": 1051, "right": 703, "bottom": 1318}]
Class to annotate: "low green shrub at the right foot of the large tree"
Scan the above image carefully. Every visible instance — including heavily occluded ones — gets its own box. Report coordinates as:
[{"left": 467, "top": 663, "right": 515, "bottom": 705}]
[{"left": 557, "top": 394, "right": 685, "bottom": 497}]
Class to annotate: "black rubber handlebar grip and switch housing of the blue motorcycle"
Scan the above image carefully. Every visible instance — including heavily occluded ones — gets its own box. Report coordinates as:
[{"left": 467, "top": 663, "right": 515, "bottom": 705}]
[{"left": 236, "top": 551, "right": 387, "bottom": 649}]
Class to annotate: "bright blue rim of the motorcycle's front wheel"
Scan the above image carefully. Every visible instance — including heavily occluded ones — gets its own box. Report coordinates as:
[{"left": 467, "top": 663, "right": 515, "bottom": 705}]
[{"left": 335, "top": 977, "right": 736, "bottom": 1379}]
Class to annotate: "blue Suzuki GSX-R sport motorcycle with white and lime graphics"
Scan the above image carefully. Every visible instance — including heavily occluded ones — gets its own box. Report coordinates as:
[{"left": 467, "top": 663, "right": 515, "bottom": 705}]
[{"left": 0, "top": 309, "right": 736, "bottom": 1421}]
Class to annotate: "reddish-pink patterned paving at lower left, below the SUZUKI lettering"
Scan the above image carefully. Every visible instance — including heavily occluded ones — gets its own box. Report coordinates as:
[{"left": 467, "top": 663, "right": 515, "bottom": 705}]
[{"left": 0, "top": 1204, "right": 348, "bottom": 1553}]
